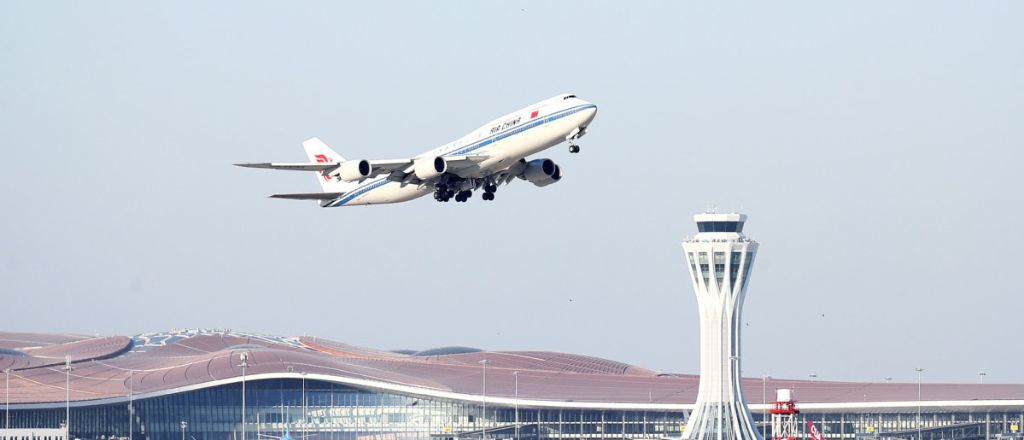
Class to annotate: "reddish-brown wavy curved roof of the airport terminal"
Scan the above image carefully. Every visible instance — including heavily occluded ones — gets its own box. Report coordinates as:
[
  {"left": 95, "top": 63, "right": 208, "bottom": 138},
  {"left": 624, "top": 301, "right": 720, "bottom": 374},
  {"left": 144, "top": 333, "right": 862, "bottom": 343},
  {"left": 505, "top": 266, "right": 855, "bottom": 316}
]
[{"left": 0, "top": 329, "right": 1024, "bottom": 410}]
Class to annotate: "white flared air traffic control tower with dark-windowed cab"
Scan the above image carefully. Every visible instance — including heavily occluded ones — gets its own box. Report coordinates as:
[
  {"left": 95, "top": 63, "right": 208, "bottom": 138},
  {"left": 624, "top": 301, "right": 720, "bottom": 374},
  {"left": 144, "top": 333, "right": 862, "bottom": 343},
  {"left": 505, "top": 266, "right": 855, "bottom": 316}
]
[{"left": 683, "top": 213, "right": 761, "bottom": 440}]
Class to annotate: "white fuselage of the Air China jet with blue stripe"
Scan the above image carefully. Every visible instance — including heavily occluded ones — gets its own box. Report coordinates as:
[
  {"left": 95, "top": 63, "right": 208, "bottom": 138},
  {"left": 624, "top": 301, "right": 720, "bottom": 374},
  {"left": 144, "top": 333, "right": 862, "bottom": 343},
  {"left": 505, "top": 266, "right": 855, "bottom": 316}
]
[{"left": 324, "top": 95, "right": 597, "bottom": 207}]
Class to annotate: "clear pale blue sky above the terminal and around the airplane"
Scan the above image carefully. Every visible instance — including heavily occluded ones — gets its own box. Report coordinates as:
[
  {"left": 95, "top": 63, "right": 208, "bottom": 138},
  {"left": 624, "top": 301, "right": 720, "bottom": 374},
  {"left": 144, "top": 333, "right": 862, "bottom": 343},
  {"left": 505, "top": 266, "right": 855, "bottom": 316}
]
[{"left": 0, "top": 1, "right": 1024, "bottom": 383}]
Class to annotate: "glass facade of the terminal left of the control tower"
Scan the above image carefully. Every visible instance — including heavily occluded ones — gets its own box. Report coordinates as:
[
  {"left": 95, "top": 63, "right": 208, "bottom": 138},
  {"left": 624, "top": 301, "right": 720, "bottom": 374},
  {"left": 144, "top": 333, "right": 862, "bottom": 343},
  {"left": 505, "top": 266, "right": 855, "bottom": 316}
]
[{"left": 11, "top": 380, "right": 686, "bottom": 440}]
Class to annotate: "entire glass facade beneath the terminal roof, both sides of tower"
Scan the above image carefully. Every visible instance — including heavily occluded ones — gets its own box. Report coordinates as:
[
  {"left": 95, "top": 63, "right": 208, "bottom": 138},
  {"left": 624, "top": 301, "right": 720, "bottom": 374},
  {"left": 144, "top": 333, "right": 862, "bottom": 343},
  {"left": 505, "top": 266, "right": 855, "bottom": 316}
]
[{"left": 4, "top": 379, "right": 1024, "bottom": 440}]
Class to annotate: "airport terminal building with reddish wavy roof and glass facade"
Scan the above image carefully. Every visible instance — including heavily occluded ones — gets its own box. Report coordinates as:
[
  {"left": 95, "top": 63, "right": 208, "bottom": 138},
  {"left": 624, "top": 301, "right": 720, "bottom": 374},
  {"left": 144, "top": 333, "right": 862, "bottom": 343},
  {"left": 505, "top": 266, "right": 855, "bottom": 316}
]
[{"left": 0, "top": 329, "right": 1024, "bottom": 440}]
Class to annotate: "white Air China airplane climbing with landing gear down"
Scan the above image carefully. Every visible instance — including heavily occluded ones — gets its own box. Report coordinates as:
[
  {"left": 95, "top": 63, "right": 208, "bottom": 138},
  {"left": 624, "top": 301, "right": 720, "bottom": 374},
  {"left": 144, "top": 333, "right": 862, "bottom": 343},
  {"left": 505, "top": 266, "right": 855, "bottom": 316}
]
[{"left": 234, "top": 93, "right": 597, "bottom": 208}]
